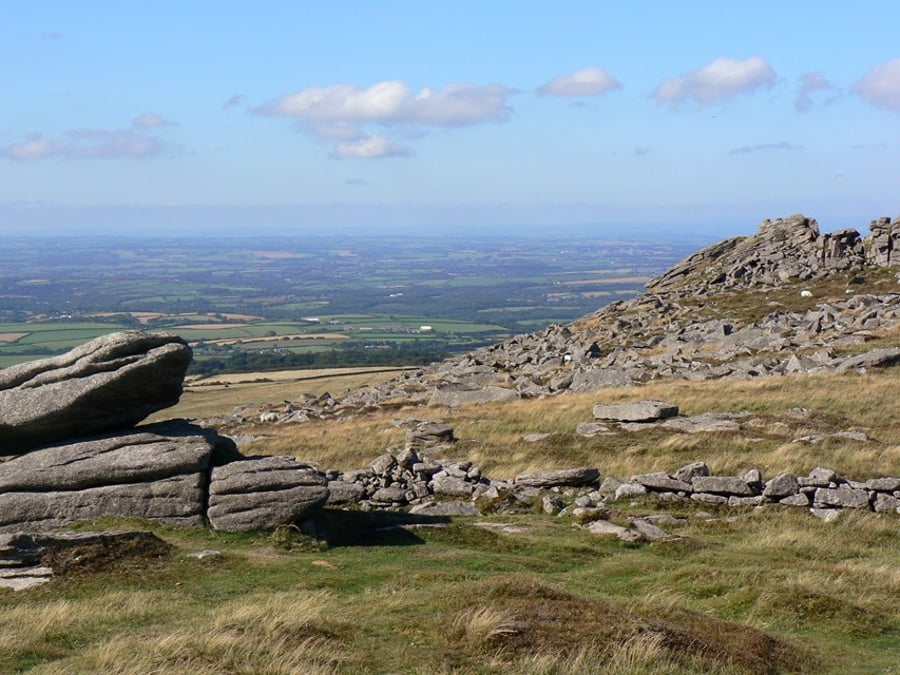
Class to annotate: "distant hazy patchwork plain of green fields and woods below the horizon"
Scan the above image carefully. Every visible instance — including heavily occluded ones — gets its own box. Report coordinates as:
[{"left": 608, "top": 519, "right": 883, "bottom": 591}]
[{"left": 0, "top": 234, "right": 694, "bottom": 372}]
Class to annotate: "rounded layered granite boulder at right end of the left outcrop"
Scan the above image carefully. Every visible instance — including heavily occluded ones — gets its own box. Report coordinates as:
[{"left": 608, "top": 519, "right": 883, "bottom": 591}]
[{"left": 207, "top": 457, "right": 328, "bottom": 532}]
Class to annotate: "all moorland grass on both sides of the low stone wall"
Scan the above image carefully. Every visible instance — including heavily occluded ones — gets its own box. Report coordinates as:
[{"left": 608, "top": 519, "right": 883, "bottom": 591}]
[{"left": 7, "top": 362, "right": 900, "bottom": 674}]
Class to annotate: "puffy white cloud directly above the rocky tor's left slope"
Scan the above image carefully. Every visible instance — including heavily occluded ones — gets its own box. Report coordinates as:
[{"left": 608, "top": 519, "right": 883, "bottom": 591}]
[{"left": 653, "top": 56, "right": 775, "bottom": 105}]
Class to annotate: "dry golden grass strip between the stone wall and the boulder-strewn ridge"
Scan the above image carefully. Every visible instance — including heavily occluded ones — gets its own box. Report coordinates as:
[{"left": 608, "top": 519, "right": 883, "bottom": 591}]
[{"left": 221, "top": 369, "right": 900, "bottom": 479}]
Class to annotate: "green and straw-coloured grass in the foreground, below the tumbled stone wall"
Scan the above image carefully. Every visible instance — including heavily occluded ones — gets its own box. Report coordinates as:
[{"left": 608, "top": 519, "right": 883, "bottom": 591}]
[{"left": 0, "top": 508, "right": 900, "bottom": 674}]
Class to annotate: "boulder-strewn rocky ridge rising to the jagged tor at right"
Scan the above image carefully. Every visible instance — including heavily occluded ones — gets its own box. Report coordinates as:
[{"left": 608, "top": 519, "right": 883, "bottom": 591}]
[{"left": 234, "top": 215, "right": 900, "bottom": 424}]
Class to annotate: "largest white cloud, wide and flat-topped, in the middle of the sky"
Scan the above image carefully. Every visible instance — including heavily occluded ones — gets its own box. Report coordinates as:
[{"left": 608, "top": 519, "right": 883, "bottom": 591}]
[{"left": 253, "top": 80, "right": 516, "bottom": 159}]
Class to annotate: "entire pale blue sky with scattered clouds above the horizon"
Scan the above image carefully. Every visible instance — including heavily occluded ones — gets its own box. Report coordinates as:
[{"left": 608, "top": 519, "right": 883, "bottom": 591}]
[{"left": 0, "top": 0, "right": 900, "bottom": 231}]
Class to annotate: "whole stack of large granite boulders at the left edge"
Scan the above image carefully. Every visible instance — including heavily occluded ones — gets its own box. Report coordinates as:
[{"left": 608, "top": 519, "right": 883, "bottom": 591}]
[{"left": 0, "top": 331, "right": 328, "bottom": 532}]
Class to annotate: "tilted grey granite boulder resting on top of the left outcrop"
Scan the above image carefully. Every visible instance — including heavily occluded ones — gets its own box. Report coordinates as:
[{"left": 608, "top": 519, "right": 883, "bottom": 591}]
[{"left": 0, "top": 331, "right": 191, "bottom": 455}]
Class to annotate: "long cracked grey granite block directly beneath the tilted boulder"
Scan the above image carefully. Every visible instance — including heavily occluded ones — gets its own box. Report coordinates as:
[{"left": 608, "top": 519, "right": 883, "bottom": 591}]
[{"left": 0, "top": 421, "right": 224, "bottom": 532}]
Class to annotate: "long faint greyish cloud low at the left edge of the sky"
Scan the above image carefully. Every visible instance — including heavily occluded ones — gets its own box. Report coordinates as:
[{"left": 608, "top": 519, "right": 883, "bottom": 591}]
[{"left": 0, "top": 129, "right": 167, "bottom": 161}]
